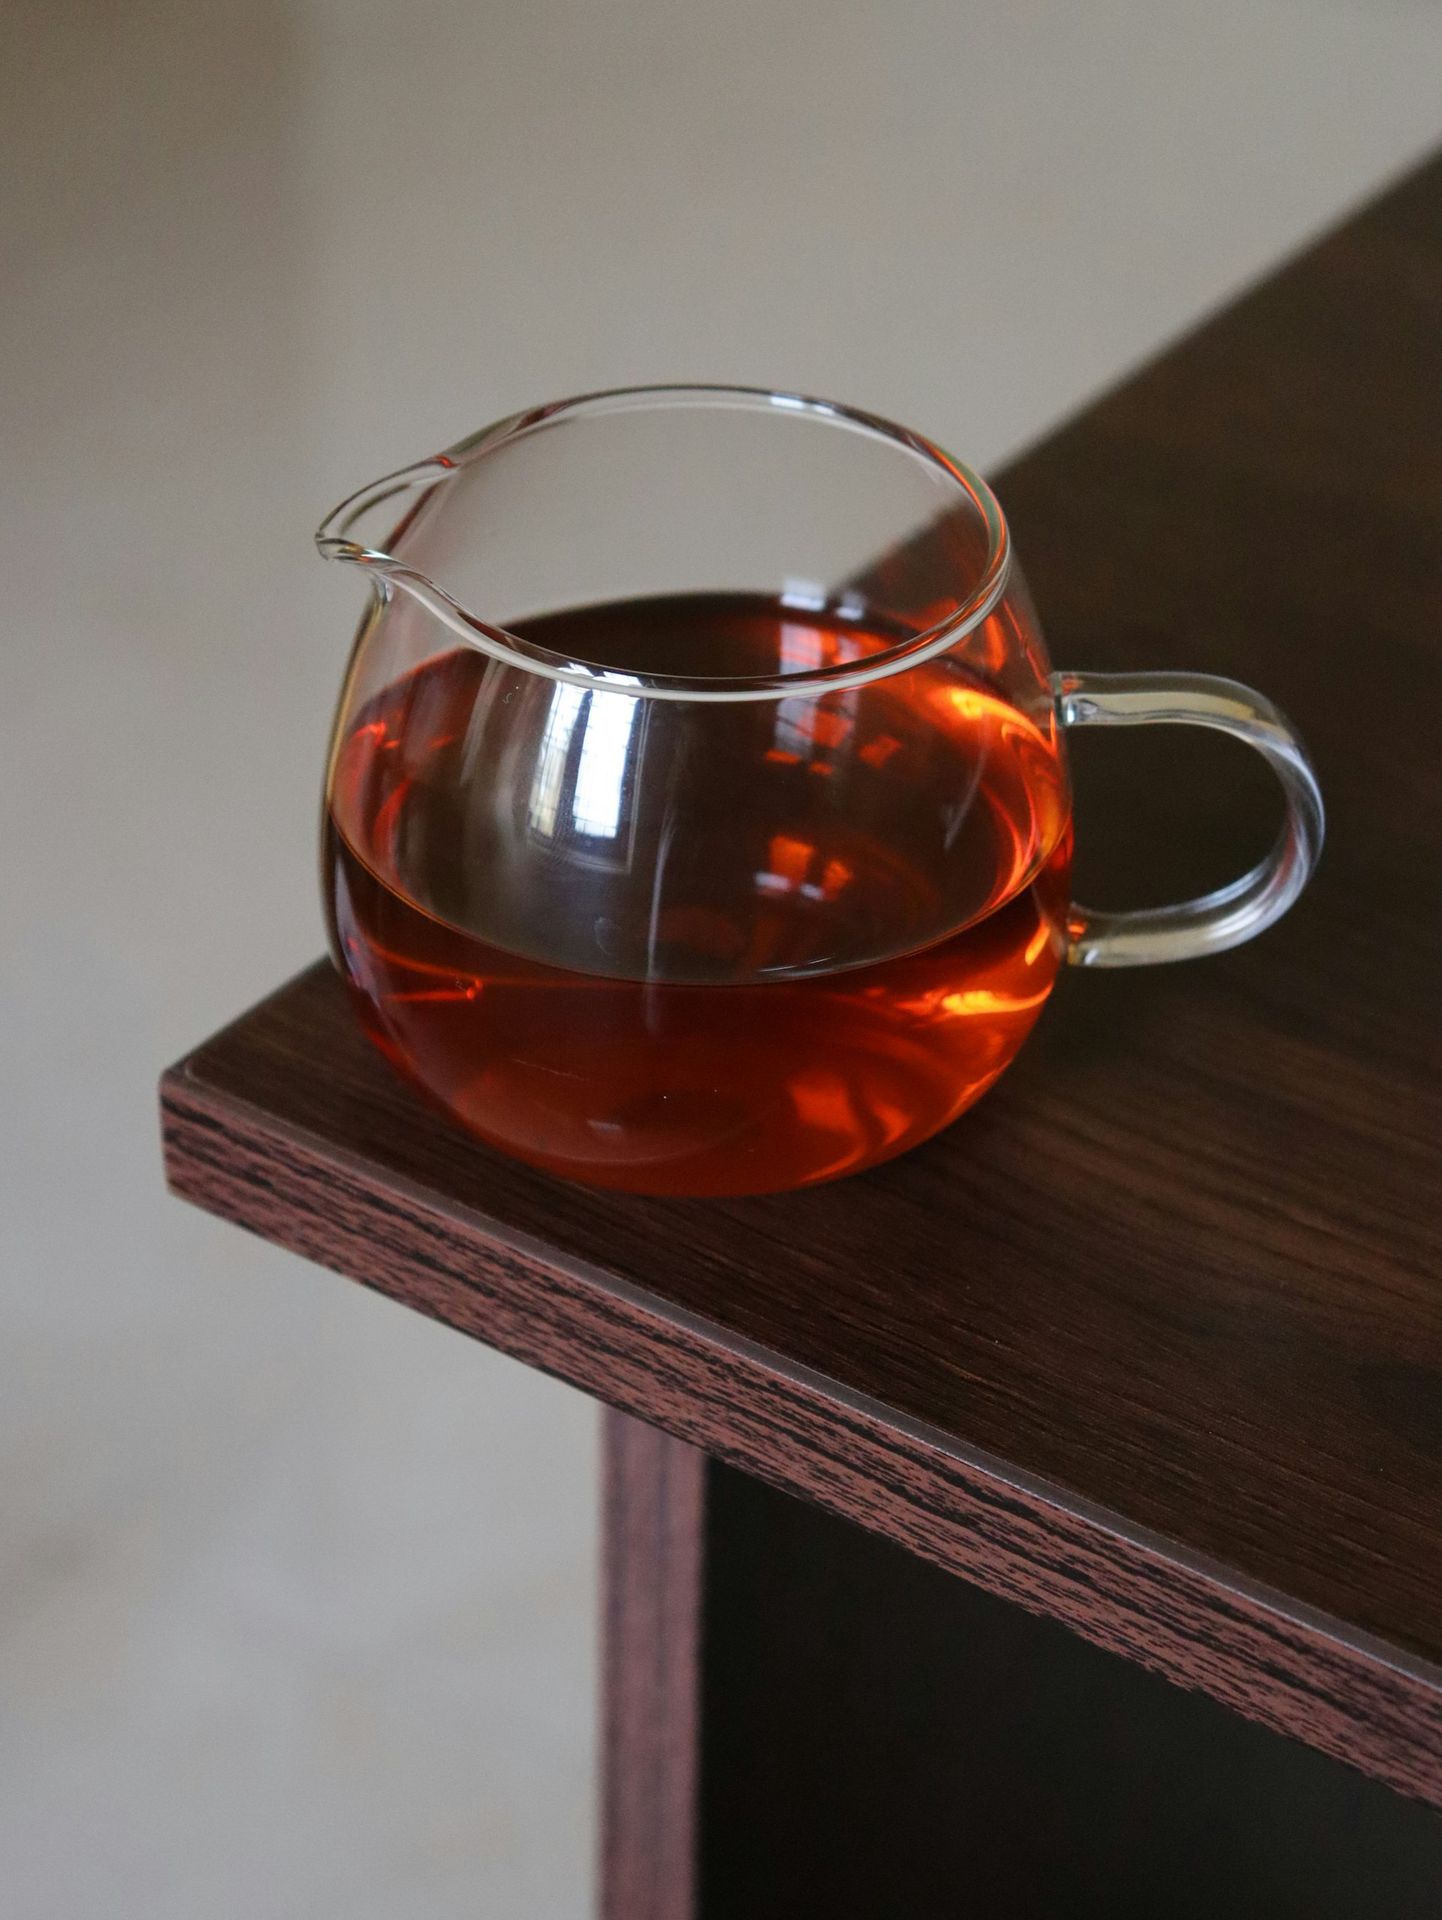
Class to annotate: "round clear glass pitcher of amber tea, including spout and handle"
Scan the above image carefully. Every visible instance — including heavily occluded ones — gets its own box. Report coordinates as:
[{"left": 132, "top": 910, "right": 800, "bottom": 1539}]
[{"left": 317, "top": 386, "right": 1323, "bottom": 1194}]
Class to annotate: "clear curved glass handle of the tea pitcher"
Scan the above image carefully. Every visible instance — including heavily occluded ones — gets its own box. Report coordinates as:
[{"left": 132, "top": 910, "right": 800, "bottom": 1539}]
[{"left": 1052, "top": 674, "right": 1325, "bottom": 966}]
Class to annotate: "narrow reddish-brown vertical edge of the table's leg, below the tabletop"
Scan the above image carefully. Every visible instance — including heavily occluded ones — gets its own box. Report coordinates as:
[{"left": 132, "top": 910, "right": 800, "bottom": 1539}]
[{"left": 599, "top": 1411, "right": 705, "bottom": 1920}]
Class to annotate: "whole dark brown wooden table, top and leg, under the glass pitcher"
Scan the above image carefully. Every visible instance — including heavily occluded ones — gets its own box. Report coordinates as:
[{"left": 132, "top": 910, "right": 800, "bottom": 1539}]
[{"left": 163, "top": 163, "right": 1442, "bottom": 1920}]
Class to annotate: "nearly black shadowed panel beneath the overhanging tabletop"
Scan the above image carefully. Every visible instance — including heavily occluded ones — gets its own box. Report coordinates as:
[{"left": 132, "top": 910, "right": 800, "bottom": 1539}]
[{"left": 698, "top": 1442, "right": 1442, "bottom": 1920}]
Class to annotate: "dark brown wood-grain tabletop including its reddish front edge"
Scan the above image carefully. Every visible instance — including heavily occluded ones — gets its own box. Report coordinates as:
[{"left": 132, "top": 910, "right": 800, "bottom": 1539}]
[{"left": 163, "top": 145, "right": 1442, "bottom": 1805}]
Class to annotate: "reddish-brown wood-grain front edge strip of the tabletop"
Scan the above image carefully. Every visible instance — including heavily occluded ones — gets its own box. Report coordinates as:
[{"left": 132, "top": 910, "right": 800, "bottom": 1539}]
[{"left": 161, "top": 1021, "right": 1442, "bottom": 1807}]
